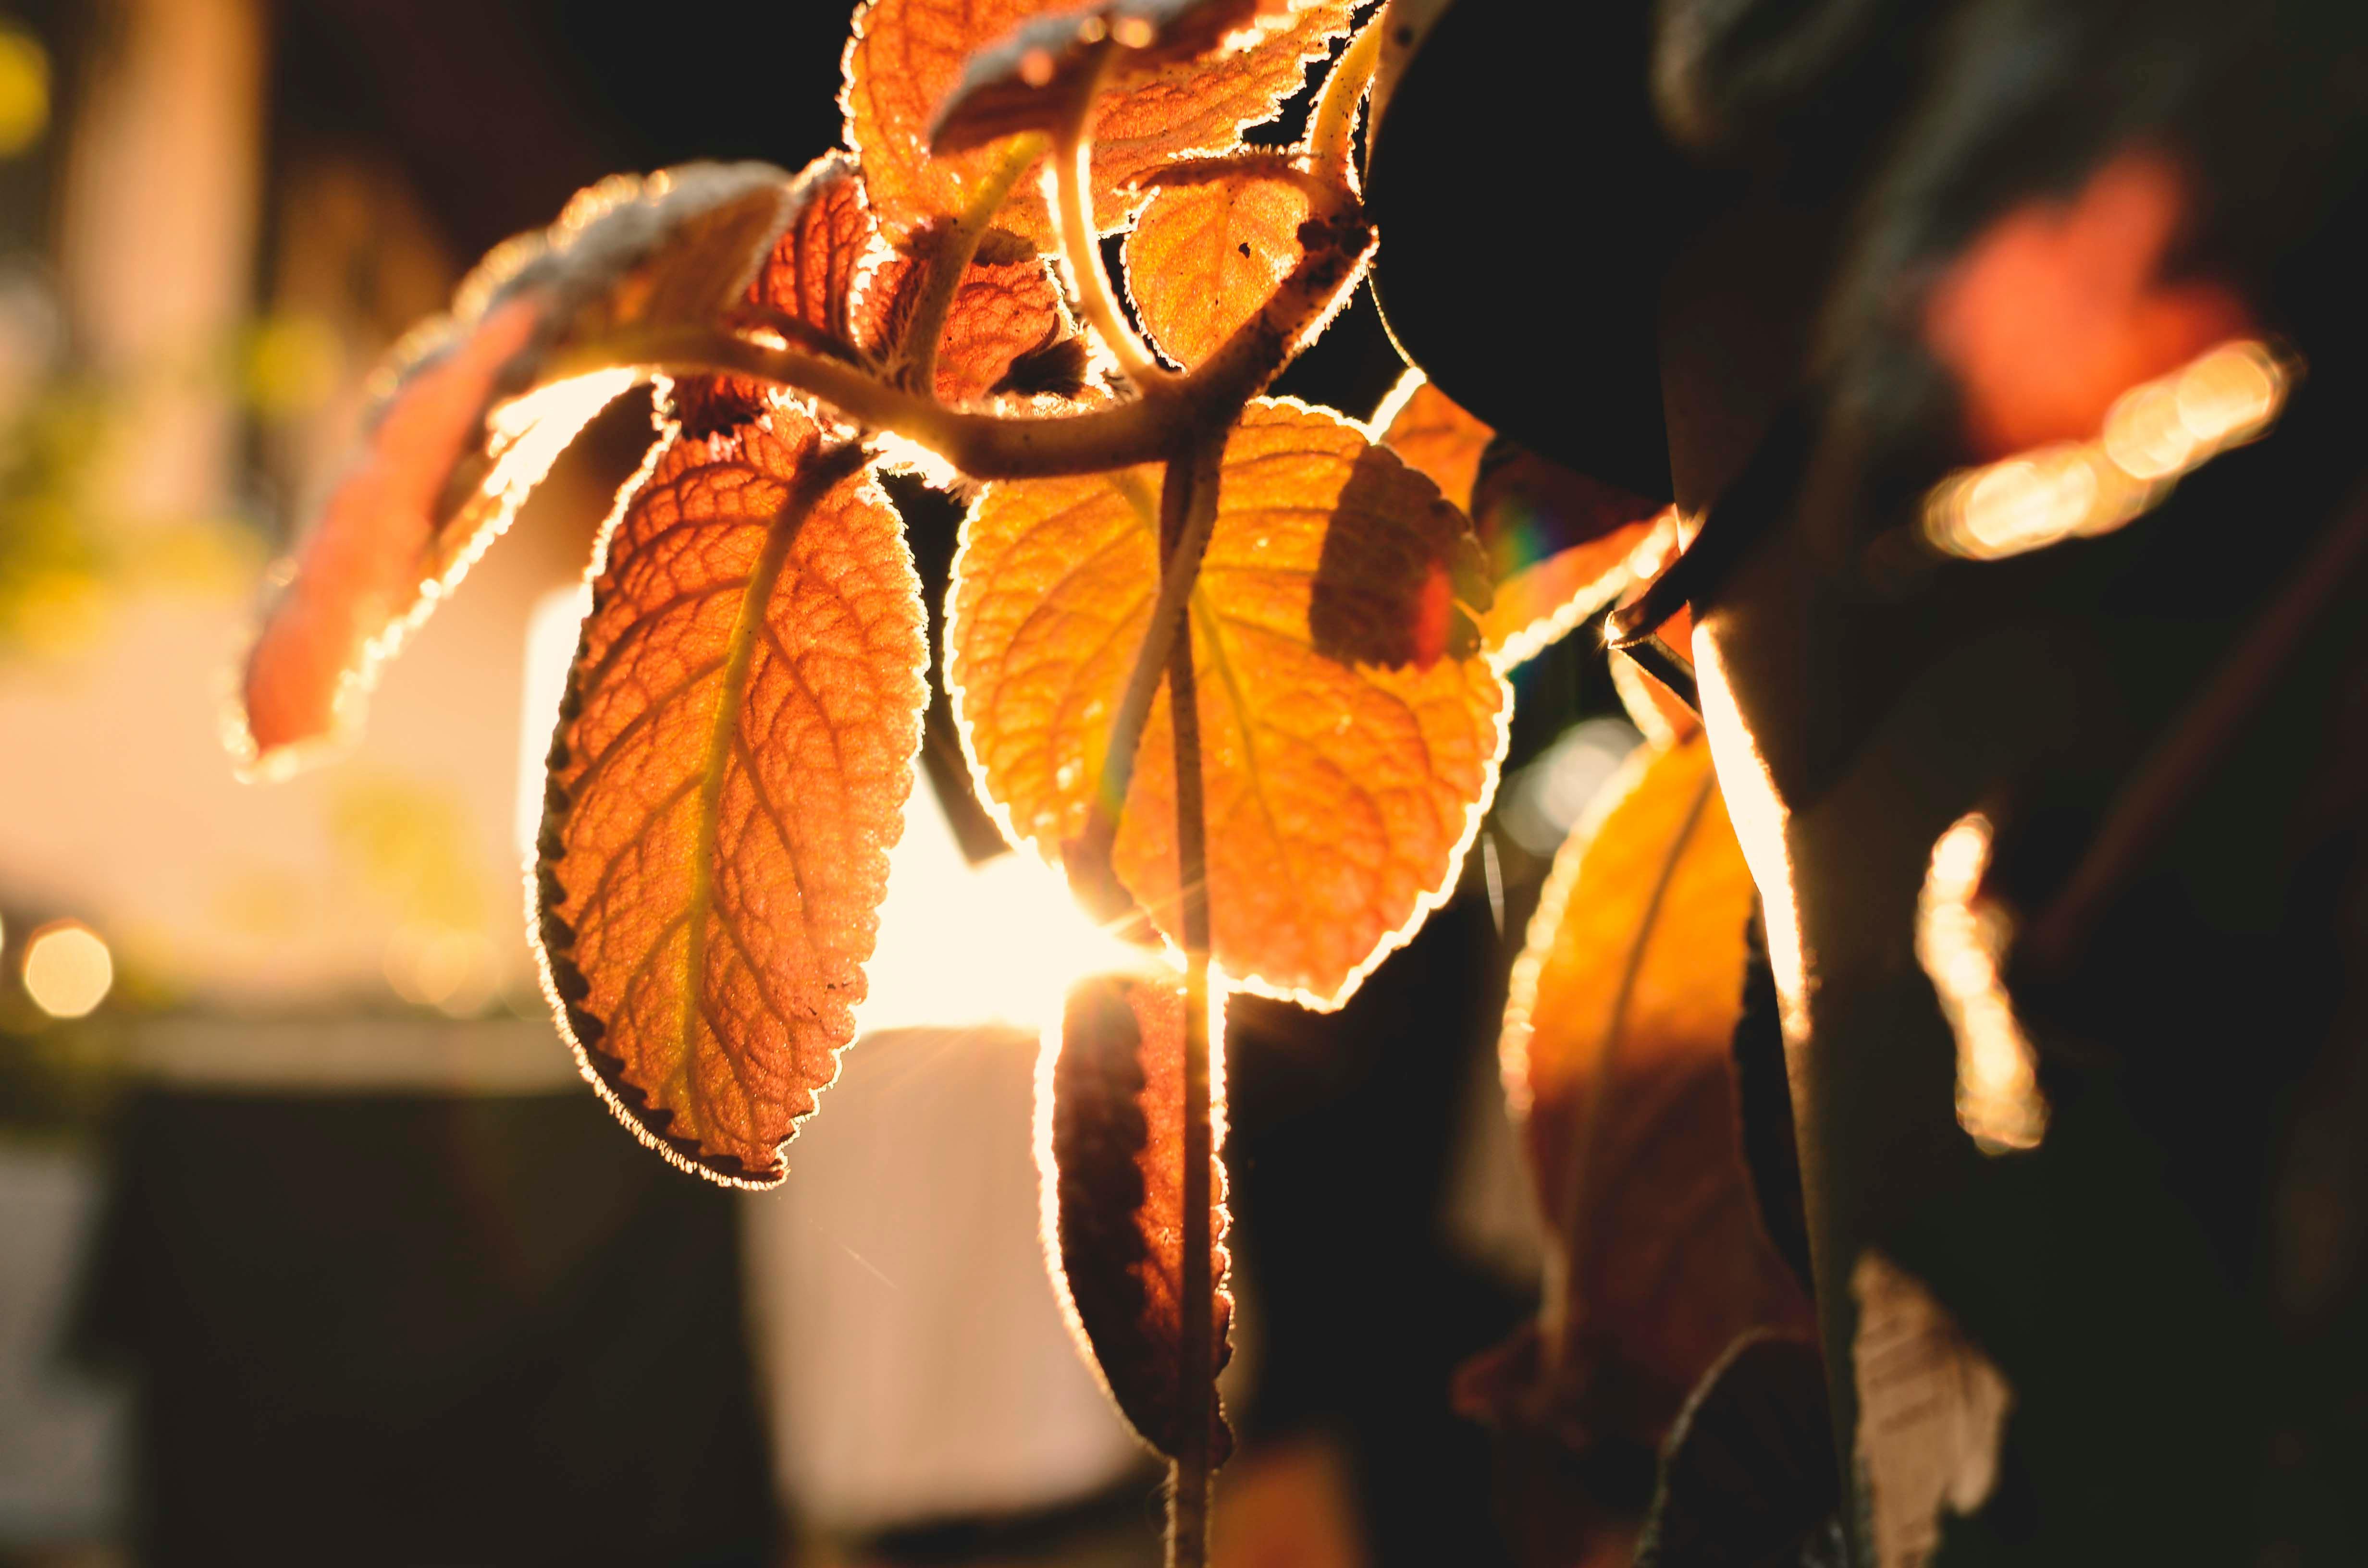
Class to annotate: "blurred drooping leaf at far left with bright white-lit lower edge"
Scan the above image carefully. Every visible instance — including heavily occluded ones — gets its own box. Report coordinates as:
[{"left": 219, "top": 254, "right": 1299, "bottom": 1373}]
[{"left": 234, "top": 163, "right": 807, "bottom": 772}]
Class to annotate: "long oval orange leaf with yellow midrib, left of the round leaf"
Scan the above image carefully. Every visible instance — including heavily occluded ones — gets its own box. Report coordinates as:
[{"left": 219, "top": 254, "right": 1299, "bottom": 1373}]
[{"left": 538, "top": 403, "right": 928, "bottom": 1184}]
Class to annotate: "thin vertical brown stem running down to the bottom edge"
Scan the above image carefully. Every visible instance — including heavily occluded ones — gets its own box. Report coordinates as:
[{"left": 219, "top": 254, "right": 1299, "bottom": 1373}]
[{"left": 1160, "top": 431, "right": 1224, "bottom": 1568}]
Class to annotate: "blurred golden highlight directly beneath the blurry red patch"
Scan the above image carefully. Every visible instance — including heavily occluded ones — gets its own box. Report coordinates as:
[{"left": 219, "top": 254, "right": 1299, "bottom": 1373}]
[{"left": 1923, "top": 341, "right": 2292, "bottom": 562}]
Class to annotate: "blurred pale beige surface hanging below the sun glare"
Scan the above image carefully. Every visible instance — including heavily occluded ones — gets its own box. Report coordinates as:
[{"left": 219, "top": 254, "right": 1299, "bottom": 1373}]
[{"left": 743, "top": 1028, "right": 1144, "bottom": 1530}]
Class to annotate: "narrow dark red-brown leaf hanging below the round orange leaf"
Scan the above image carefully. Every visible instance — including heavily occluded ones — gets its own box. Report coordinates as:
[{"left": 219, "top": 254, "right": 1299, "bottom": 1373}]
[{"left": 1037, "top": 973, "right": 1233, "bottom": 1464}]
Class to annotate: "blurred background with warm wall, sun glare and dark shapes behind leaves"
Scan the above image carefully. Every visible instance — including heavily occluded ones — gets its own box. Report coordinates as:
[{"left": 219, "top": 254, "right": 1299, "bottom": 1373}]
[{"left": 0, "top": 0, "right": 1636, "bottom": 1568}]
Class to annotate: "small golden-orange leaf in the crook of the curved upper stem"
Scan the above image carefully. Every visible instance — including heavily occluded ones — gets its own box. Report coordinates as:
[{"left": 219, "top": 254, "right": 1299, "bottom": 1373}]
[{"left": 1127, "top": 166, "right": 1316, "bottom": 369}]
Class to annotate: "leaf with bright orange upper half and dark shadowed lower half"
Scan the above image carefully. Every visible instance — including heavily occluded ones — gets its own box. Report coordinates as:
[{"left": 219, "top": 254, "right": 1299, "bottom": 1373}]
[{"left": 1504, "top": 734, "right": 1809, "bottom": 1445}]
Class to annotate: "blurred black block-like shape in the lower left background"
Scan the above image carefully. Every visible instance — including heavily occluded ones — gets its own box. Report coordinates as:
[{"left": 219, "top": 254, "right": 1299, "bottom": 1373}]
[{"left": 83, "top": 1094, "right": 774, "bottom": 1568}]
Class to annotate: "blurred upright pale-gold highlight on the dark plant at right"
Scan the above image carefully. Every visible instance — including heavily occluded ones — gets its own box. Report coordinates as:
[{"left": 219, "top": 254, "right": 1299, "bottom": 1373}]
[{"left": 1916, "top": 812, "right": 2048, "bottom": 1153}]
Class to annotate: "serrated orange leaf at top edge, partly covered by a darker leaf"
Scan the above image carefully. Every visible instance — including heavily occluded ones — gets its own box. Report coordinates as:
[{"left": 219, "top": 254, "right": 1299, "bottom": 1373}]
[{"left": 840, "top": 0, "right": 1355, "bottom": 246}]
